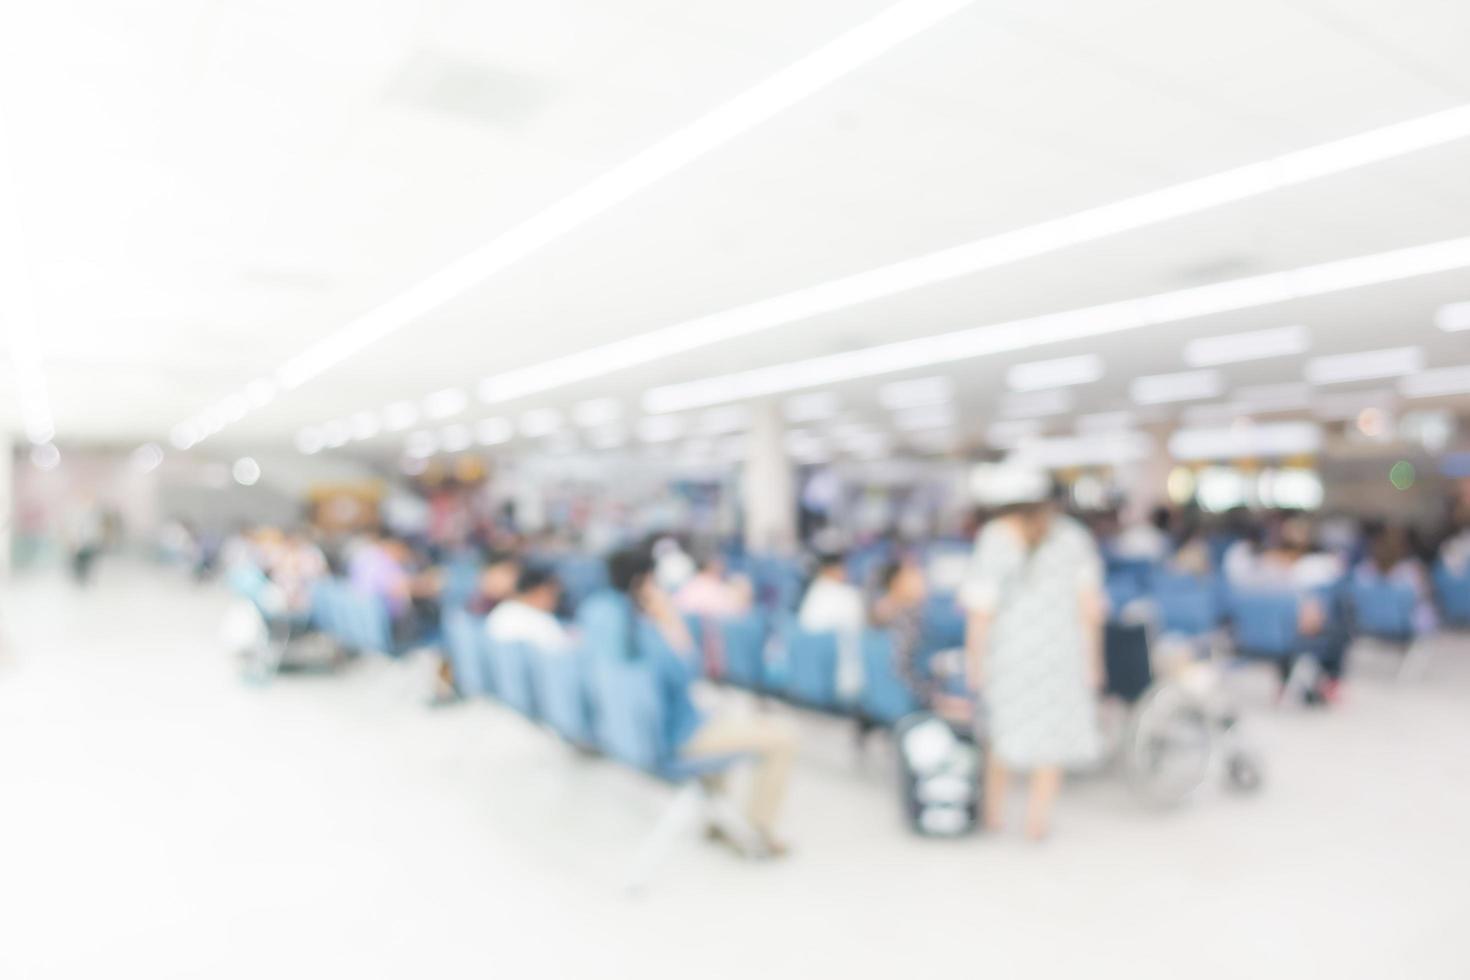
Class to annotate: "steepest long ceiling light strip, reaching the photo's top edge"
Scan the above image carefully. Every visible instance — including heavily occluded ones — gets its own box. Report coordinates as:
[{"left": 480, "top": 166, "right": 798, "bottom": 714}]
[{"left": 169, "top": 0, "right": 975, "bottom": 449}]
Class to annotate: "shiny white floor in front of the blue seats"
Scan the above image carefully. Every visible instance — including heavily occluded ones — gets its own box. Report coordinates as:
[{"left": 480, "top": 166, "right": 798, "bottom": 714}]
[{"left": 0, "top": 564, "right": 1470, "bottom": 980}]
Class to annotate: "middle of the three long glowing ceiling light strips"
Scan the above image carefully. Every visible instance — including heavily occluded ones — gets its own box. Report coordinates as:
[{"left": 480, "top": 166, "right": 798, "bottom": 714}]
[{"left": 481, "top": 104, "right": 1470, "bottom": 401}]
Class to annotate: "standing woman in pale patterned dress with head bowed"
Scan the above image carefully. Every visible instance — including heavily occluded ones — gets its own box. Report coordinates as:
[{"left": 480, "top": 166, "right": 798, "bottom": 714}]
[{"left": 961, "top": 466, "right": 1105, "bottom": 840}]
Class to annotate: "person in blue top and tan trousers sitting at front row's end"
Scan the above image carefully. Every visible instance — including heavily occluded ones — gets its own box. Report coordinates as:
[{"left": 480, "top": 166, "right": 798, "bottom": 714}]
[{"left": 582, "top": 550, "right": 797, "bottom": 857}]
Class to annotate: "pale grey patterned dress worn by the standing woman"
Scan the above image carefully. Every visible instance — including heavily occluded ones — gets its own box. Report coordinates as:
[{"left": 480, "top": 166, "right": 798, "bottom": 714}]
[{"left": 963, "top": 516, "right": 1103, "bottom": 770}]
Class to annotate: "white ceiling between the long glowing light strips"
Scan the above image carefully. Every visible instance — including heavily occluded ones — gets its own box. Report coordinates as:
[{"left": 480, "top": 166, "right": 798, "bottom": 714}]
[{"left": 0, "top": 0, "right": 1470, "bottom": 458}]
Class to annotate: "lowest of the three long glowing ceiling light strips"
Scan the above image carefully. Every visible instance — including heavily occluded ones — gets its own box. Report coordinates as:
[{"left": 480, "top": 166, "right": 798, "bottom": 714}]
[{"left": 642, "top": 238, "right": 1470, "bottom": 413}]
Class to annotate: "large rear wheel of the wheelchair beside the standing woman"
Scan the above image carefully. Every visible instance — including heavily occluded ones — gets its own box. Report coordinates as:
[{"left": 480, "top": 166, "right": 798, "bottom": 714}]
[{"left": 1122, "top": 685, "right": 1214, "bottom": 807}]
